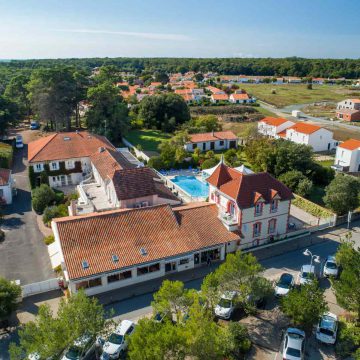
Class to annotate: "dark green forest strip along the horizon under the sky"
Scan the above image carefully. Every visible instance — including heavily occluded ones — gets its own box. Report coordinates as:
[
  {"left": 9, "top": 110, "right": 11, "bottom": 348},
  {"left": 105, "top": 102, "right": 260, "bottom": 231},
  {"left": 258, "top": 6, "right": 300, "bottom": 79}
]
[{"left": 0, "top": 57, "right": 360, "bottom": 79}]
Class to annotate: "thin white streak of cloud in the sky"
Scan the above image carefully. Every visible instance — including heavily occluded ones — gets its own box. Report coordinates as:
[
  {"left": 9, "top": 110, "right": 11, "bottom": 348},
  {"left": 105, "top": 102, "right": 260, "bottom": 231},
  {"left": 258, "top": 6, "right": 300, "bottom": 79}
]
[{"left": 53, "top": 29, "right": 193, "bottom": 41}]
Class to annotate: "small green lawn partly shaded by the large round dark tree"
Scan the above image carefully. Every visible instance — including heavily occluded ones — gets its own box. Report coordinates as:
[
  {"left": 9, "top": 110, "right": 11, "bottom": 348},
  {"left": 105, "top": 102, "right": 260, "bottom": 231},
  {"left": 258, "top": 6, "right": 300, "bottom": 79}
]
[{"left": 125, "top": 130, "right": 171, "bottom": 151}]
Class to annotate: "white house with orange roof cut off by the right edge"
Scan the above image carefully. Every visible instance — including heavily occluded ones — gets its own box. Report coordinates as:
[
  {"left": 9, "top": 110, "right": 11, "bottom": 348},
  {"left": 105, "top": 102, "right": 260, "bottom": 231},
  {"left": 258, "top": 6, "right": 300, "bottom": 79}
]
[{"left": 332, "top": 139, "right": 360, "bottom": 172}]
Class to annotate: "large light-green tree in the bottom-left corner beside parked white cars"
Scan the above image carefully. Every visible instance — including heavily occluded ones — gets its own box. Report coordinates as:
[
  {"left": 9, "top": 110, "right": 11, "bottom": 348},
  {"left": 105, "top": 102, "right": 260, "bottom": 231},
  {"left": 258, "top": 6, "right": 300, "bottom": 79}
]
[{"left": 10, "top": 291, "right": 112, "bottom": 360}]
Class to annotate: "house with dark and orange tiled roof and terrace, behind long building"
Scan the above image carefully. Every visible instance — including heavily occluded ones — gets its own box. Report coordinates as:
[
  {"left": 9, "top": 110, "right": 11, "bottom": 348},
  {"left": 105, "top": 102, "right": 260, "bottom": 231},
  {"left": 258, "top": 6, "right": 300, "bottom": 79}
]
[{"left": 74, "top": 148, "right": 181, "bottom": 215}]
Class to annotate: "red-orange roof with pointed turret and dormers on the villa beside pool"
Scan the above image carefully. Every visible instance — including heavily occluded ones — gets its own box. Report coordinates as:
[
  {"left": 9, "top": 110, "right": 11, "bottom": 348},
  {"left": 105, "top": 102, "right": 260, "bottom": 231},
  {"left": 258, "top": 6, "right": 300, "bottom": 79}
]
[{"left": 207, "top": 164, "right": 293, "bottom": 209}]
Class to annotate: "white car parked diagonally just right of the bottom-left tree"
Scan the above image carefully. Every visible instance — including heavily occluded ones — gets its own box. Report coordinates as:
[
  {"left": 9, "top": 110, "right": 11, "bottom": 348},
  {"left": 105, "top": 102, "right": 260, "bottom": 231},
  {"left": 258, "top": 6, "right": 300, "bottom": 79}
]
[{"left": 100, "top": 320, "right": 135, "bottom": 360}]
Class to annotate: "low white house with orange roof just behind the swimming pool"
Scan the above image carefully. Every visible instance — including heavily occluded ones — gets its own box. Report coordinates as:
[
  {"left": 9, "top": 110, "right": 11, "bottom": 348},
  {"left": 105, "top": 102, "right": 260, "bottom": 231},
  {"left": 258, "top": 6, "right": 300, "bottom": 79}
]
[{"left": 184, "top": 131, "right": 239, "bottom": 152}]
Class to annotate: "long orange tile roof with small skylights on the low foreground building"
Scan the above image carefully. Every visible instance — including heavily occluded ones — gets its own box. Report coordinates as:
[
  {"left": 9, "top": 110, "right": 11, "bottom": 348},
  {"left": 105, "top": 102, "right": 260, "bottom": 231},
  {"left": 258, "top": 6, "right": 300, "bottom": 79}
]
[{"left": 54, "top": 204, "right": 239, "bottom": 279}]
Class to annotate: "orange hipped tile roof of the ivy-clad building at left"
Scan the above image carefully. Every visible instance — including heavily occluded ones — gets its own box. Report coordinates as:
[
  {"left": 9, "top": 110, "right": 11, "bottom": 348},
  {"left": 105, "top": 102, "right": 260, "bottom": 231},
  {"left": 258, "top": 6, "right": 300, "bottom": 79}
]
[{"left": 28, "top": 131, "right": 114, "bottom": 163}]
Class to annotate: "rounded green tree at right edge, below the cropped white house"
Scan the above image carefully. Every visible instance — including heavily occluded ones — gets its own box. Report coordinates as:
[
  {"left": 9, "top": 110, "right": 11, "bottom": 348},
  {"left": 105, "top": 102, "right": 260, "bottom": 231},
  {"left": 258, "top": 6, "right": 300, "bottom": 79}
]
[{"left": 324, "top": 174, "right": 360, "bottom": 215}]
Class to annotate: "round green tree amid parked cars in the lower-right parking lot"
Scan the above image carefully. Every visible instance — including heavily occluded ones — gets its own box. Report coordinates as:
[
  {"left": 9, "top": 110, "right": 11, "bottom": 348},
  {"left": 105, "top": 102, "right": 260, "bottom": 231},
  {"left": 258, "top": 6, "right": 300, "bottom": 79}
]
[{"left": 281, "top": 279, "right": 328, "bottom": 332}]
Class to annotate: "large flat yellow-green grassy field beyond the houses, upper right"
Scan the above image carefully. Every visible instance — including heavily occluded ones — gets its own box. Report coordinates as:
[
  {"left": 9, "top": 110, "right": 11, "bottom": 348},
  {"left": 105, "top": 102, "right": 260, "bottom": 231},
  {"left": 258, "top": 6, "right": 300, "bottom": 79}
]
[{"left": 235, "top": 84, "right": 360, "bottom": 108}]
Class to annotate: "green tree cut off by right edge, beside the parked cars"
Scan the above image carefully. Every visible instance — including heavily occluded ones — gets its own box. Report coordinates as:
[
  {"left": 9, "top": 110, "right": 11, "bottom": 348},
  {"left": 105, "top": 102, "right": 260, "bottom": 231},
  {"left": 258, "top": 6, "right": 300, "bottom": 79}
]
[{"left": 332, "top": 235, "right": 360, "bottom": 322}]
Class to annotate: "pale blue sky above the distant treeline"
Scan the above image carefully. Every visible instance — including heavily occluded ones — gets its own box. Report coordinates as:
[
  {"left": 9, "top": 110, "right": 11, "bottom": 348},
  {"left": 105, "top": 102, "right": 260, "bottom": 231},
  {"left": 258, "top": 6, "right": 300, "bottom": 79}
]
[{"left": 0, "top": 0, "right": 360, "bottom": 59}]
